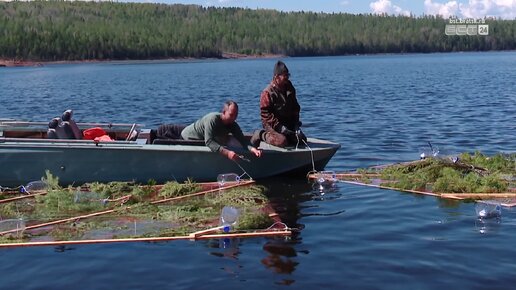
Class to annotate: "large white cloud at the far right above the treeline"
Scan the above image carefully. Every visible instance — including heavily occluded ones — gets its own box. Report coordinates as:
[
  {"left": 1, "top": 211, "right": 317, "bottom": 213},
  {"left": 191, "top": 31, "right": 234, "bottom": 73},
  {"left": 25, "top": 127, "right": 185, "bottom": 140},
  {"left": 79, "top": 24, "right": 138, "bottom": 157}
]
[{"left": 425, "top": 0, "right": 516, "bottom": 19}]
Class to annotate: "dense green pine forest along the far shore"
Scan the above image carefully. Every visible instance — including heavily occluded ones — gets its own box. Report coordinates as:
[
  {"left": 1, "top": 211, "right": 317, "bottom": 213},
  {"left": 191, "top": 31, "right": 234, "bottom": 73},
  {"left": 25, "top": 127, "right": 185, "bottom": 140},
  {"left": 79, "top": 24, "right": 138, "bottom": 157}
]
[{"left": 0, "top": 1, "right": 516, "bottom": 61}]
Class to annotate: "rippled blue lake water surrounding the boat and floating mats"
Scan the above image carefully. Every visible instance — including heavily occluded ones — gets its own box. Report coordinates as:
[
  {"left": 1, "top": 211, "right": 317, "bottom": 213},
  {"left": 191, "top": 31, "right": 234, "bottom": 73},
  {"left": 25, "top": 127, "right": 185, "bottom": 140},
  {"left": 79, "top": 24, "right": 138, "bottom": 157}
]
[{"left": 0, "top": 52, "right": 516, "bottom": 289}]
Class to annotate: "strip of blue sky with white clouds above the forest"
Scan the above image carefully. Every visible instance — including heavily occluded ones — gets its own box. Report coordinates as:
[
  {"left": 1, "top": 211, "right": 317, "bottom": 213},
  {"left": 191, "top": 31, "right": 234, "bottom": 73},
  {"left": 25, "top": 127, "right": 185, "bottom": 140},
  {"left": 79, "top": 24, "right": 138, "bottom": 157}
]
[{"left": 155, "top": 0, "right": 516, "bottom": 20}]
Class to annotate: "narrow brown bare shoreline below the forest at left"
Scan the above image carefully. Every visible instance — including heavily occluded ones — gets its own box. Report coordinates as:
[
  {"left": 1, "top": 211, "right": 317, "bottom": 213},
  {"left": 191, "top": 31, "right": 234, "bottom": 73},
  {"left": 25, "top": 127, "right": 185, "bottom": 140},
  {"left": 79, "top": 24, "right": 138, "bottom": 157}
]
[{"left": 0, "top": 52, "right": 288, "bottom": 67}]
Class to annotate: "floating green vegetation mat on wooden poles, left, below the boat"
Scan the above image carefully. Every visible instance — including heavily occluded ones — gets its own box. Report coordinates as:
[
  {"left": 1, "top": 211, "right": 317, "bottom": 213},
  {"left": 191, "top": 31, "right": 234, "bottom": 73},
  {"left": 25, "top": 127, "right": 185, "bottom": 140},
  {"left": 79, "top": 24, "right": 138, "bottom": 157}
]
[{"left": 0, "top": 173, "right": 282, "bottom": 243}]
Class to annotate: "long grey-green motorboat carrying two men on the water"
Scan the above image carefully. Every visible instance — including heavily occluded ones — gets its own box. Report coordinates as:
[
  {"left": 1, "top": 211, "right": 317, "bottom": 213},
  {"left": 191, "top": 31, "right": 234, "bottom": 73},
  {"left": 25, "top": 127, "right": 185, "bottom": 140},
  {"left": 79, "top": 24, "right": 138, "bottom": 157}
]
[{"left": 0, "top": 119, "right": 340, "bottom": 187}]
